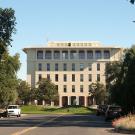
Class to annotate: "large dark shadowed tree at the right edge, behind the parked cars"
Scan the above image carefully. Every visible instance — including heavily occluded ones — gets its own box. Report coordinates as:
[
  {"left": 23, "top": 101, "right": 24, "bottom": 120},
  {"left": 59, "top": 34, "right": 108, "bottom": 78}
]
[{"left": 106, "top": 46, "right": 135, "bottom": 112}]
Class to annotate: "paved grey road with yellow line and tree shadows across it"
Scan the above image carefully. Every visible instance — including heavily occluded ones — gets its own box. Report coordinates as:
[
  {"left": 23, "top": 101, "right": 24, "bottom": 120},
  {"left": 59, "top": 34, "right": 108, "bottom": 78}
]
[{"left": 0, "top": 115, "right": 131, "bottom": 135}]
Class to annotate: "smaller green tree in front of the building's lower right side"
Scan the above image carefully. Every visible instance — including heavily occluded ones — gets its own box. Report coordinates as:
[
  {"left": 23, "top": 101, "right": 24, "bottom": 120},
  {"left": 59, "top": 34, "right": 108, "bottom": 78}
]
[{"left": 89, "top": 82, "right": 106, "bottom": 104}]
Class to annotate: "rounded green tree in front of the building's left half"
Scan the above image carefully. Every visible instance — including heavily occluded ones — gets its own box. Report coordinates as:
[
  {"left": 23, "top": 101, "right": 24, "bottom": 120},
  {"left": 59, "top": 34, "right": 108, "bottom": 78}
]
[{"left": 38, "top": 78, "right": 58, "bottom": 101}]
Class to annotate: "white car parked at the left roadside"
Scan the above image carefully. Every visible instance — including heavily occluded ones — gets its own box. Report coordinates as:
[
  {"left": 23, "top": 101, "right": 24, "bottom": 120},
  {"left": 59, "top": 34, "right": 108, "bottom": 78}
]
[{"left": 7, "top": 105, "right": 21, "bottom": 117}]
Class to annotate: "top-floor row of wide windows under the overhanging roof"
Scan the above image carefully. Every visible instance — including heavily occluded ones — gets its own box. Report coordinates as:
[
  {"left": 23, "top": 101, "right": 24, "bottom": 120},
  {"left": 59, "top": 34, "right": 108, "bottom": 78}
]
[{"left": 37, "top": 50, "right": 110, "bottom": 60}]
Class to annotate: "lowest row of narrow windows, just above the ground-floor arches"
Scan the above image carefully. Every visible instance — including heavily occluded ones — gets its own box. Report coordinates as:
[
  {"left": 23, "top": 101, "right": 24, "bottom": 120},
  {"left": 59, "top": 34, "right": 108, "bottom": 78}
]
[{"left": 56, "top": 85, "right": 91, "bottom": 93}]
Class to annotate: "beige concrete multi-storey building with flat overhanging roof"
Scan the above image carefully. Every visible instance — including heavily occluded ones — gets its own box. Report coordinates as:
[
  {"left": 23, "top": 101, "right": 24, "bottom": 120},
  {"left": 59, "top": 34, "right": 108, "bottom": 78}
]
[{"left": 23, "top": 41, "right": 122, "bottom": 106}]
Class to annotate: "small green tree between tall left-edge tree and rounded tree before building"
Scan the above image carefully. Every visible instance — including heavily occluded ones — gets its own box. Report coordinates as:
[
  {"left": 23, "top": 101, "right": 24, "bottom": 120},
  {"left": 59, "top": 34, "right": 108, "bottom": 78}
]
[{"left": 17, "top": 81, "right": 31, "bottom": 104}]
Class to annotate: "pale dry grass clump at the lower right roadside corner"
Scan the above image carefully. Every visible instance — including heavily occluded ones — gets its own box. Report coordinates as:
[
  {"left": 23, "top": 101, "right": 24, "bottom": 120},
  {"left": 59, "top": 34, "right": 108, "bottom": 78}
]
[{"left": 113, "top": 114, "right": 135, "bottom": 131}]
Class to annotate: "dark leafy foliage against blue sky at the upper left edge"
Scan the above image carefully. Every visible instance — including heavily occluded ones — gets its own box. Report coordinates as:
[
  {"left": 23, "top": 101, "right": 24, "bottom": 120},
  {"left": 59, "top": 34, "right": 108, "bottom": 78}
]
[{"left": 0, "top": 8, "right": 16, "bottom": 60}]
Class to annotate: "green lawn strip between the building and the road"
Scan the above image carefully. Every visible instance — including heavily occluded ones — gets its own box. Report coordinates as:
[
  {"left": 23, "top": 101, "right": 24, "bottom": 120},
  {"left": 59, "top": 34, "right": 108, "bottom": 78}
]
[{"left": 21, "top": 105, "right": 95, "bottom": 114}]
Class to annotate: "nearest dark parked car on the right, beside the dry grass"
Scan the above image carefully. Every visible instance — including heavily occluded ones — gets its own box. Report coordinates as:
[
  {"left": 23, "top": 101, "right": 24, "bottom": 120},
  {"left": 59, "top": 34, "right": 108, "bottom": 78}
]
[{"left": 105, "top": 105, "right": 122, "bottom": 120}]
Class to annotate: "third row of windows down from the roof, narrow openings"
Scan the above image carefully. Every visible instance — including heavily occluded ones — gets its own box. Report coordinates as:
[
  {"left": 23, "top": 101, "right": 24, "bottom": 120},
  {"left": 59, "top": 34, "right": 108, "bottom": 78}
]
[{"left": 39, "top": 74, "right": 100, "bottom": 82}]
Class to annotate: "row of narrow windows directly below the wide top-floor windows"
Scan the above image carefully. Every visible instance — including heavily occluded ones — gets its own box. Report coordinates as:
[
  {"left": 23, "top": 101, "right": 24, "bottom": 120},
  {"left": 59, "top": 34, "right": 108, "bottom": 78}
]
[{"left": 38, "top": 63, "right": 100, "bottom": 71}]
